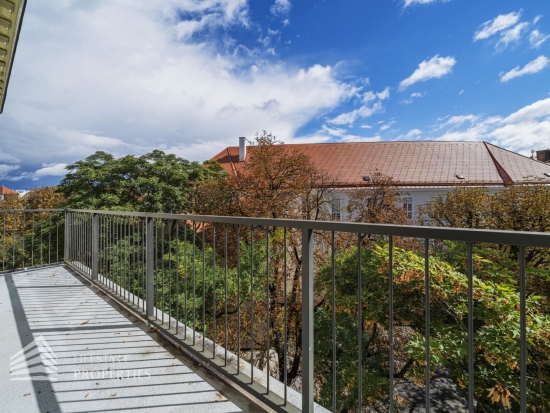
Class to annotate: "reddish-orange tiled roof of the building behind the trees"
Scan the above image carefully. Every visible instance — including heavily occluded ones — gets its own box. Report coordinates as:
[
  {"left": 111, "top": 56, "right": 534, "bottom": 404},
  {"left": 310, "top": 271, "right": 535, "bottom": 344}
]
[{"left": 212, "top": 141, "right": 550, "bottom": 186}]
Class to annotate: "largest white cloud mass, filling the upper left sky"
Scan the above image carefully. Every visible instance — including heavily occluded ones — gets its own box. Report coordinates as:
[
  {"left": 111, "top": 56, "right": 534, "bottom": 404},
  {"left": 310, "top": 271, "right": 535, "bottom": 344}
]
[{"left": 0, "top": 0, "right": 353, "bottom": 175}]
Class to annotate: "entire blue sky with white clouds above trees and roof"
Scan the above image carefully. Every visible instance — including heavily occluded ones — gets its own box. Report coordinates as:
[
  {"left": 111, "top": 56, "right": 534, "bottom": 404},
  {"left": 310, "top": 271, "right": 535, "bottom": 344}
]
[{"left": 0, "top": 0, "right": 550, "bottom": 189}]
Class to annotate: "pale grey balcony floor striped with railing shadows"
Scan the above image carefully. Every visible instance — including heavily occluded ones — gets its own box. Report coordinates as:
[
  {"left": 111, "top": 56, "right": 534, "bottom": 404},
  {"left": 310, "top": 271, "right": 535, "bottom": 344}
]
[{"left": 0, "top": 266, "right": 242, "bottom": 413}]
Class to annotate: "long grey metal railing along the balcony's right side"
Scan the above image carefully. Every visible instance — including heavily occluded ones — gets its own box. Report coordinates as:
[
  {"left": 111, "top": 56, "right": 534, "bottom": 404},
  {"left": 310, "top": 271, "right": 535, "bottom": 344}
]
[{"left": 0, "top": 209, "right": 550, "bottom": 412}]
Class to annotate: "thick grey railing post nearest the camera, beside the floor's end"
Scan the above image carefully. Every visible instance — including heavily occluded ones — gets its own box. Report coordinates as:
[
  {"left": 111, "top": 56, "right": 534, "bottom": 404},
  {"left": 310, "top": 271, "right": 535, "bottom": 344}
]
[{"left": 302, "top": 228, "right": 314, "bottom": 413}]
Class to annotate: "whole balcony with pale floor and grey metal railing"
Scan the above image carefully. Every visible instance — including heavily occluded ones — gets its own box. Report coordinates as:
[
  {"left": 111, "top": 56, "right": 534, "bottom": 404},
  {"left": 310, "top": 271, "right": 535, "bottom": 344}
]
[{"left": 0, "top": 210, "right": 550, "bottom": 412}]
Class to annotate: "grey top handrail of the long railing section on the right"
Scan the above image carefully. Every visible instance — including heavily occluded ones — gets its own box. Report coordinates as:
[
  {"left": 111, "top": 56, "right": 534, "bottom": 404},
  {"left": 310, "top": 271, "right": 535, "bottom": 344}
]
[{"left": 67, "top": 209, "right": 550, "bottom": 248}]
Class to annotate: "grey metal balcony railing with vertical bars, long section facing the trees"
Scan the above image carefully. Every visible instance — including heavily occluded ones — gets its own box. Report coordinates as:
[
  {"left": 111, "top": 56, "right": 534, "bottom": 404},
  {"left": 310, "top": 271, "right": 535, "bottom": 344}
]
[{"left": 4, "top": 210, "right": 550, "bottom": 412}]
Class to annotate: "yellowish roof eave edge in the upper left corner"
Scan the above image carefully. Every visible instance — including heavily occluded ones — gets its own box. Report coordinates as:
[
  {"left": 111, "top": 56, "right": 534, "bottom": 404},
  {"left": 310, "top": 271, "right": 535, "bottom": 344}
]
[{"left": 0, "top": 0, "right": 27, "bottom": 114}]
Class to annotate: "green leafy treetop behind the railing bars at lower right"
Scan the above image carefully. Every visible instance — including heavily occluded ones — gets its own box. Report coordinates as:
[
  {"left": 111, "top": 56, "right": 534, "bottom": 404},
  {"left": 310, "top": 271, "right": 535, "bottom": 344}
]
[{"left": 315, "top": 243, "right": 550, "bottom": 412}]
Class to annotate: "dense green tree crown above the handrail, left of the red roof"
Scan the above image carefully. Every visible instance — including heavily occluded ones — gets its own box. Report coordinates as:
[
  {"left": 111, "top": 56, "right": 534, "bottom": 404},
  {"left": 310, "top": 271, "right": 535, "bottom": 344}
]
[{"left": 58, "top": 150, "right": 216, "bottom": 213}]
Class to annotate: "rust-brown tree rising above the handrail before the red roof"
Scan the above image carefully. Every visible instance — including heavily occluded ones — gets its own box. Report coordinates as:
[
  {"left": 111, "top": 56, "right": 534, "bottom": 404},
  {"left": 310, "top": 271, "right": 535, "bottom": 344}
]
[{"left": 193, "top": 131, "right": 340, "bottom": 383}]
